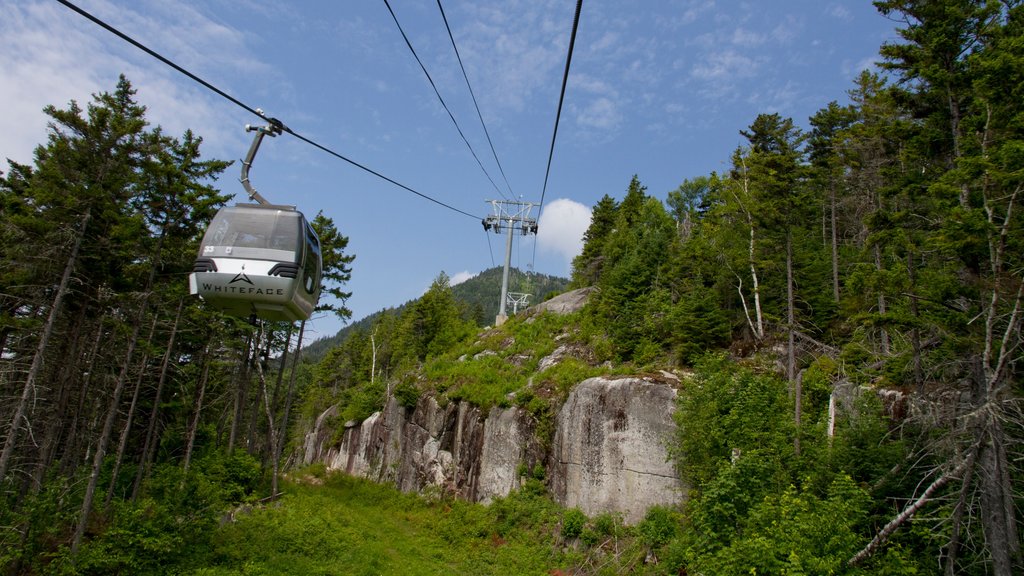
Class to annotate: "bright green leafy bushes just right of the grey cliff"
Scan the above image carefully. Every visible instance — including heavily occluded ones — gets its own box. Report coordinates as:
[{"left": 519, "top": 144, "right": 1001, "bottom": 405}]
[{"left": 667, "top": 356, "right": 918, "bottom": 574}]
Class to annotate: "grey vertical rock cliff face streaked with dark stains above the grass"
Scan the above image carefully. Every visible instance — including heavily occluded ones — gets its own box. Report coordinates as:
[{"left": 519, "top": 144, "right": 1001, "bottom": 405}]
[{"left": 303, "top": 378, "right": 682, "bottom": 523}]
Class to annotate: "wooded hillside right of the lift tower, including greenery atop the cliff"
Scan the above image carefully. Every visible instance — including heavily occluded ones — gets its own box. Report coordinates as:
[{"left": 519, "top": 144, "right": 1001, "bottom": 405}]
[{"left": 296, "top": 2, "right": 1024, "bottom": 575}]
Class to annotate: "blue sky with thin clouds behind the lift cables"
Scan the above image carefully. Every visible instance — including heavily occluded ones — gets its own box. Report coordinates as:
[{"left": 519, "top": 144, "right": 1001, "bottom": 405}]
[{"left": 0, "top": 0, "right": 896, "bottom": 337}]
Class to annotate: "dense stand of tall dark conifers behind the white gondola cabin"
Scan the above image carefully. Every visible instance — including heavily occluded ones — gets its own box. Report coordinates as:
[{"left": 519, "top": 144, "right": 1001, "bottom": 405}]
[{"left": 0, "top": 77, "right": 352, "bottom": 573}]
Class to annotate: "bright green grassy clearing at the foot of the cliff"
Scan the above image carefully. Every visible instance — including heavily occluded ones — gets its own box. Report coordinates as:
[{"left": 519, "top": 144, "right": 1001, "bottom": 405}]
[{"left": 191, "top": 475, "right": 574, "bottom": 576}]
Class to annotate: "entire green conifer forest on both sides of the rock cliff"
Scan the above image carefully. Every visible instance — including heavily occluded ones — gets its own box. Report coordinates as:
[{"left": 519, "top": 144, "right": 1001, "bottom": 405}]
[{"left": 0, "top": 0, "right": 1024, "bottom": 576}]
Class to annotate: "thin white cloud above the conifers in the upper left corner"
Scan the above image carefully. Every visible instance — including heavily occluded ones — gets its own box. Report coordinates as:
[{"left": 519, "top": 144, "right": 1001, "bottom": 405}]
[{"left": 0, "top": 2, "right": 269, "bottom": 163}]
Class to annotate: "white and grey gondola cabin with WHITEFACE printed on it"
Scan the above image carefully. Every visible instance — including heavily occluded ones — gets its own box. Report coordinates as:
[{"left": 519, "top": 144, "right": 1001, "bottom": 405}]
[{"left": 188, "top": 204, "right": 321, "bottom": 321}]
